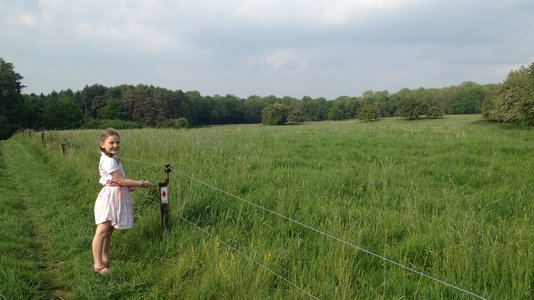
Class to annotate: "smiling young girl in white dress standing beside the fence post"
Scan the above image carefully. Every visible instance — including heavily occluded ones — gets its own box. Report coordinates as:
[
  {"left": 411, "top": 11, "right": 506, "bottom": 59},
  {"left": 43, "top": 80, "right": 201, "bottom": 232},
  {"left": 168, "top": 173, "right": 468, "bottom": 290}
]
[{"left": 92, "top": 128, "right": 152, "bottom": 274}]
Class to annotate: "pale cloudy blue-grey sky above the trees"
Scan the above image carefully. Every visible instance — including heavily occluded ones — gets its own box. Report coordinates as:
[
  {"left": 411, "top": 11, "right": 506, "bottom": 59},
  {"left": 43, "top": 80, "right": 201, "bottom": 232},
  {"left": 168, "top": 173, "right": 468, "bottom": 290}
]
[{"left": 0, "top": 0, "right": 534, "bottom": 100}]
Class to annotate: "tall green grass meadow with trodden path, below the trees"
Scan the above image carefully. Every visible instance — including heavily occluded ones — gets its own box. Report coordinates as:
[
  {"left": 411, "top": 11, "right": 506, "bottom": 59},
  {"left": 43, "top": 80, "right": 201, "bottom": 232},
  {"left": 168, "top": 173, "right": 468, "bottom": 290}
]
[{"left": 0, "top": 115, "right": 534, "bottom": 299}]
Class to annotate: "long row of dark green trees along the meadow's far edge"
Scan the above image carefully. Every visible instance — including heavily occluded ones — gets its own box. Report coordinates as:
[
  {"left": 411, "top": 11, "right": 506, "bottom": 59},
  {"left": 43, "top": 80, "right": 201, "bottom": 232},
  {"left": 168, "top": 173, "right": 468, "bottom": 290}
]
[{"left": 0, "top": 58, "right": 534, "bottom": 138}]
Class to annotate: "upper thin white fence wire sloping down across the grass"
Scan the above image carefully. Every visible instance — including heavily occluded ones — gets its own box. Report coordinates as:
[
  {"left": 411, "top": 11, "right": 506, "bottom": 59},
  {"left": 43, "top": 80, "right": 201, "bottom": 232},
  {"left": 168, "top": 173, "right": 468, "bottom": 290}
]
[{"left": 124, "top": 159, "right": 486, "bottom": 300}]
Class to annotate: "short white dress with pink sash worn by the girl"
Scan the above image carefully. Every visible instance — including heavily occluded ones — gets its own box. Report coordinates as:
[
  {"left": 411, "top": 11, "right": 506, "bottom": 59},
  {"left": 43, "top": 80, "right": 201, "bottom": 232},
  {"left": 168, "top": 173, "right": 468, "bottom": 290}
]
[{"left": 95, "top": 153, "right": 133, "bottom": 229}]
